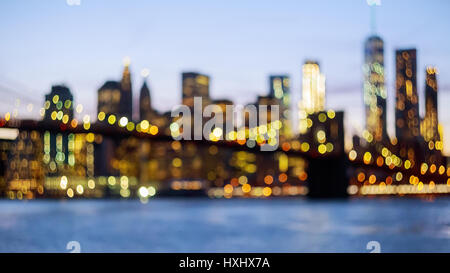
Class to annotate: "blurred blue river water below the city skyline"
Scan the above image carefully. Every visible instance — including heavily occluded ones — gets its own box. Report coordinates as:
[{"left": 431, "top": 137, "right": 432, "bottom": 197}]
[{"left": 0, "top": 198, "right": 450, "bottom": 252}]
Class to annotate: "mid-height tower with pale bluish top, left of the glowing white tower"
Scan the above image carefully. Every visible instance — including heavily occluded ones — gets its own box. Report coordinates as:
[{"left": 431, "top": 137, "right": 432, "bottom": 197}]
[{"left": 269, "top": 75, "right": 291, "bottom": 137}]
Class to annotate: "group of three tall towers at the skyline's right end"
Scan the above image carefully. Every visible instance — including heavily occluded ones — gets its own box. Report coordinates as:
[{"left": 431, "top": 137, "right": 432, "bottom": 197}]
[{"left": 363, "top": 36, "right": 443, "bottom": 159}]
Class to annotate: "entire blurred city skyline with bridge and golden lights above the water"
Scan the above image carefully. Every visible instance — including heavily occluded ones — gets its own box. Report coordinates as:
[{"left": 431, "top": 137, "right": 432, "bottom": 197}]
[{"left": 0, "top": 31, "right": 450, "bottom": 200}]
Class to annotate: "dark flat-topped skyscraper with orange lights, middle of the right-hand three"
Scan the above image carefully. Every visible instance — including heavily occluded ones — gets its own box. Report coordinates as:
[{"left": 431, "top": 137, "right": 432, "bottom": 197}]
[{"left": 395, "top": 49, "right": 419, "bottom": 142}]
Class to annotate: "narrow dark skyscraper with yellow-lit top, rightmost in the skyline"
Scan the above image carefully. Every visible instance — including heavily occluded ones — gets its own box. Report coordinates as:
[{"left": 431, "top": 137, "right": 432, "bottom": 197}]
[{"left": 422, "top": 67, "right": 440, "bottom": 142}]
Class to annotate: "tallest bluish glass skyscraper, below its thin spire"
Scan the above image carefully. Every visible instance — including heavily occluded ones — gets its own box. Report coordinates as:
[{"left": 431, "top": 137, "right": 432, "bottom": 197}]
[{"left": 363, "top": 36, "right": 387, "bottom": 141}]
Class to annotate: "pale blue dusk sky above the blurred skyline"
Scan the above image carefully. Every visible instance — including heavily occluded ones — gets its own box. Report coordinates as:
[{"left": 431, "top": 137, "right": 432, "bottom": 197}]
[{"left": 0, "top": 0, "right": 450, "bottom": 155}]
